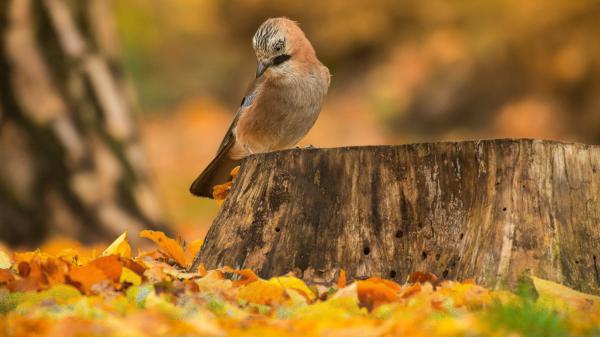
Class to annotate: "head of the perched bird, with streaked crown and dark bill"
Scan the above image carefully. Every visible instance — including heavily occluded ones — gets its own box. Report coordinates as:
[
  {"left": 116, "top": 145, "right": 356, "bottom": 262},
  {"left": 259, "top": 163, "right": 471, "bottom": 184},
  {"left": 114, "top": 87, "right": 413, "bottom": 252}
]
[{"left": 252, "top": 18, "right": 315, "bottom": 78}]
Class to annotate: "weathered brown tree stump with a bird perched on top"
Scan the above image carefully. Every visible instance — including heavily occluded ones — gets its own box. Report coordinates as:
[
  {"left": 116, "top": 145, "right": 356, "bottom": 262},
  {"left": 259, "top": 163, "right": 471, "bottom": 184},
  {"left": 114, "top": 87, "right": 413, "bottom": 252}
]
[{"left": 196, "top": 140, "right": 600, "bottom": 293}]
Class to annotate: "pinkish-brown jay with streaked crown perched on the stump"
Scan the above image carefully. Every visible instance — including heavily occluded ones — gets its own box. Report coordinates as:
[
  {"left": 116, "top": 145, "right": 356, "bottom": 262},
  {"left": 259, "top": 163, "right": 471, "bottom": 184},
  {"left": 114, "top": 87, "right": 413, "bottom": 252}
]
[{"left": 190, "top": 17, "right": 331, "bottom": 198}]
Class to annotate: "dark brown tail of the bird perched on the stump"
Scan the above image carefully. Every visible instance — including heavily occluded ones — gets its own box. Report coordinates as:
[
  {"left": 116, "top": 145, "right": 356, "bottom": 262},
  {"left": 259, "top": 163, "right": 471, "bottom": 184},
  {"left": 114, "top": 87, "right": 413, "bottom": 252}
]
[{"left": 190, "top": 150, "right": 240, "bottom": 199}]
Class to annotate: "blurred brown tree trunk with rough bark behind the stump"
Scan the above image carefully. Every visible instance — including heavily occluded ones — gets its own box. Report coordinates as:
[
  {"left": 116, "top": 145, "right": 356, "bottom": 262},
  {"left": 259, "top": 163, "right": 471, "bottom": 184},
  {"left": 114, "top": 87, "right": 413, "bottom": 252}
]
[{"left": 0, "top": 0, "right": 169, "bottom": 245}]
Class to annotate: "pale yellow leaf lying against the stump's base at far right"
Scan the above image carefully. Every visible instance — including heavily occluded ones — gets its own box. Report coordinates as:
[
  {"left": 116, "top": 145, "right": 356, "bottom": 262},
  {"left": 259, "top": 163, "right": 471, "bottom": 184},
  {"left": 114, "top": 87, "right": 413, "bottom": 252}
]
[{"left": 531, "top": 276, "right": 600, "bottom": 309}]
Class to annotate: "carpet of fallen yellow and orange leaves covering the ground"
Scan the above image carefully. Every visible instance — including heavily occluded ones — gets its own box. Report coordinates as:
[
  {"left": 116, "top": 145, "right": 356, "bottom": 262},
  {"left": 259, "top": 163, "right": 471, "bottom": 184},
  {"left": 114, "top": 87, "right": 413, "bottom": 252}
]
[{"left": 0, "top": 231, "right": 600, "bottom": 337}]
